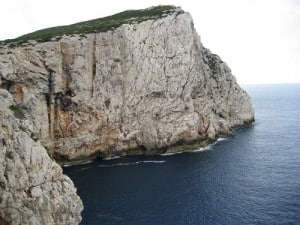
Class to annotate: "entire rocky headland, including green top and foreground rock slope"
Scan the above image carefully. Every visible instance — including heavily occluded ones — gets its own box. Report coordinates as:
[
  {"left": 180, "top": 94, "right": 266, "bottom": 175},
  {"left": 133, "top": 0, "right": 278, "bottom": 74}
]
[{"left": 0, "top": 6, "right": 254, "bottom": 224}]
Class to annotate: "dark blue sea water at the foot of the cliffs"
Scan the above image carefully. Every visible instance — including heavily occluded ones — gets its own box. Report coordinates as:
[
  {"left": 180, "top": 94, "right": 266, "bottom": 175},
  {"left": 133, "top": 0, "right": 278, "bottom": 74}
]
[{"left": 64, "top": 85, "right": 300, "bottom": 225}]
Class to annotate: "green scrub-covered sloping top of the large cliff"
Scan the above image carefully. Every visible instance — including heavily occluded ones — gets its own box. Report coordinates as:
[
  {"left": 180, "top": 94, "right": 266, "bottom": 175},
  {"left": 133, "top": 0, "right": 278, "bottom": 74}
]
[{"left": 0, "top": 5, "right": 183, "bottom": 47}]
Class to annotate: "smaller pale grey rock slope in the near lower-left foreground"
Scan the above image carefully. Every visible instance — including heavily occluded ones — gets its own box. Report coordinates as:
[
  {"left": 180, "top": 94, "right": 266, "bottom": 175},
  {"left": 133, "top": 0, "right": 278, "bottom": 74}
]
[{"left": 0, "top": 89, "right": 83, "bottom": 225}]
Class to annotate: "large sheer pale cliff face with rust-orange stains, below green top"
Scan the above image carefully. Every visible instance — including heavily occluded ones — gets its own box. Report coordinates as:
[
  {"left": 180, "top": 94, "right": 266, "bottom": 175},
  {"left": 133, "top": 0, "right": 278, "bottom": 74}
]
[{"left": 0, "top": 8, "right": 254, "bottom": 161}]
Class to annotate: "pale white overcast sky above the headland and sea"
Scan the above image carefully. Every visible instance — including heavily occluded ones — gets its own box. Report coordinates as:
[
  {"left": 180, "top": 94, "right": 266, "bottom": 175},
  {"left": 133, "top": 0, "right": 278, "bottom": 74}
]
[{"left": 0, "top": 0, "right": 300, "bottom": 84}]
